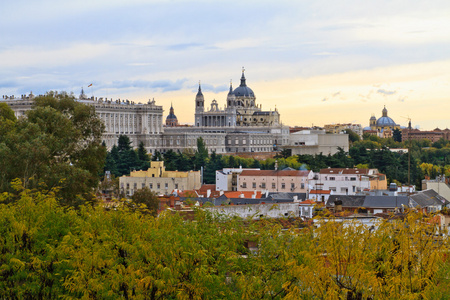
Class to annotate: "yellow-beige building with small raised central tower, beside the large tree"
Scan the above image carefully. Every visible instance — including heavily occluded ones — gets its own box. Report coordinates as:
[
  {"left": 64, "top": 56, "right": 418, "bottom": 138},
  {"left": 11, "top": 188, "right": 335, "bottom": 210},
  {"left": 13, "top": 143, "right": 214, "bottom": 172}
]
[{"left": 119, "top": 161, "right": 201, "bottom": 196}]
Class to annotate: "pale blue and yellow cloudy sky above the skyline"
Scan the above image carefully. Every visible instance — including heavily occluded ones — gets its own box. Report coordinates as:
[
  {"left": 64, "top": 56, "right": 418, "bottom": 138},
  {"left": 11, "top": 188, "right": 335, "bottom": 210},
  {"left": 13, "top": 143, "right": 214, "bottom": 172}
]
[{"left": 0, "top": 0, "right": 450, "bottom": 130}]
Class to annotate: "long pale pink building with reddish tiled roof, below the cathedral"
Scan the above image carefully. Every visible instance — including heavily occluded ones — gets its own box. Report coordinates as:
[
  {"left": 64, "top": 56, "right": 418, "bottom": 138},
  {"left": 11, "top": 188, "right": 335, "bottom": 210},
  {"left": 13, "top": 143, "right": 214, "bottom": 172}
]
[{"left": 238, "top": 170, "right": 314, "bottom": 193}]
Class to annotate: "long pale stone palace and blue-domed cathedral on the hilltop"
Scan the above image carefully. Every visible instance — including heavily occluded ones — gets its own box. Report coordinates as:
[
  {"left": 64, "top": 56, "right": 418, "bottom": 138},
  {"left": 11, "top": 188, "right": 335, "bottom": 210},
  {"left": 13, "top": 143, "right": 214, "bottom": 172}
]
[{"left": 0, "top": 72, "right": 289, "bottom": 154}]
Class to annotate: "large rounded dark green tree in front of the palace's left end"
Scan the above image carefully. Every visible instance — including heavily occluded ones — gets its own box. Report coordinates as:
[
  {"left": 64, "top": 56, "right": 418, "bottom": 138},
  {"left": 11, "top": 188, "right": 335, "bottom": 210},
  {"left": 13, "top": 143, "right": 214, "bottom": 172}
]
[{"left": 0, "top": 92, "right": 106, "bottom": 205}]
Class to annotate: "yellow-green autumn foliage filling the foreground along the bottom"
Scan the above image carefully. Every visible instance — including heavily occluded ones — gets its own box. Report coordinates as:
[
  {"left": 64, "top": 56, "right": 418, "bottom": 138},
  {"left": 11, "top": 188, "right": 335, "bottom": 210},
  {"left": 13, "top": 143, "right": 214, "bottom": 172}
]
[{"left": 0, "top": 184, "right": 450, "bottom": 300}]
